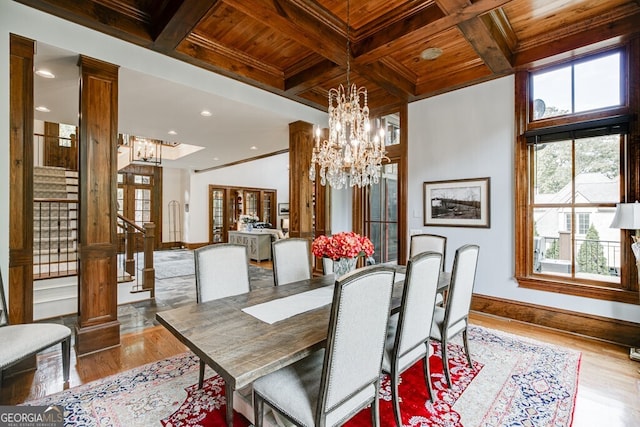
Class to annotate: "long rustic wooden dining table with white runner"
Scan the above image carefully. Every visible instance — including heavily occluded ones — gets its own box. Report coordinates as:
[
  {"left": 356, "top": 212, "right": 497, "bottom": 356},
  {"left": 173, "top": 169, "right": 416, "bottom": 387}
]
[{"left": 156, "top": 273, "right": 450, "bottom": 427}]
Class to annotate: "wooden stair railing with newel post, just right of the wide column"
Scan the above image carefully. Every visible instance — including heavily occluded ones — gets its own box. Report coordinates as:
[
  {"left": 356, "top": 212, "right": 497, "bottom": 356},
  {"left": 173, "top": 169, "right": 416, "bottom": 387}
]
[{"left": 117, "top": 214, "right": 156, "bottom": 298}]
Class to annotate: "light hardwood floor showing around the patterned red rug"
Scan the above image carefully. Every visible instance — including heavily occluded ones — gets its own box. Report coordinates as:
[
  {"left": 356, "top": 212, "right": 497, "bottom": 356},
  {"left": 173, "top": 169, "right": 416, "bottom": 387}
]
[{"left": 0, "top": 313, "right": 640, "bottom": 427}]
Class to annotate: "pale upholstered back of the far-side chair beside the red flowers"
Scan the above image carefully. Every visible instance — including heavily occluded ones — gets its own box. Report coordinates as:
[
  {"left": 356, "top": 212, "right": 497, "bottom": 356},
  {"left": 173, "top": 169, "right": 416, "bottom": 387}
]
[{"left": 271, "top": 238, "right": 311, "bottom": 286}]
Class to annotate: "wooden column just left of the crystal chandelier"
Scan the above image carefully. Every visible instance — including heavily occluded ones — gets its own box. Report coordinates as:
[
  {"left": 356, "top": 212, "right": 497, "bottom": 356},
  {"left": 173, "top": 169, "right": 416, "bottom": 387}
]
[{"left": 289, "top": 121, "right": 319, "bottom": 240}]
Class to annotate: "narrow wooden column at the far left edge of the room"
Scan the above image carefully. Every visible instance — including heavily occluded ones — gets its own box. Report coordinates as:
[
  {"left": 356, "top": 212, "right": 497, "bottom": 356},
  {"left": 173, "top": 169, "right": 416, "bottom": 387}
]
[{"left": 8, "top": 34, "right": 35, "bottom": 323}]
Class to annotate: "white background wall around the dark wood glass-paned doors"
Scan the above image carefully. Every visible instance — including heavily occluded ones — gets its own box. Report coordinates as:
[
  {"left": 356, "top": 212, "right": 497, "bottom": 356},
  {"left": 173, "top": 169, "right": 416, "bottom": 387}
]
[{"left": 184, "top": 153, "right": 289, "bottom": 243}]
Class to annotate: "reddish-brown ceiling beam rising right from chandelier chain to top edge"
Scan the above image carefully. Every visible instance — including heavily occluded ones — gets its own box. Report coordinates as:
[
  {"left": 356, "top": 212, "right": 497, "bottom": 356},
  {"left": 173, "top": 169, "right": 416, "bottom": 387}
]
[{"left": 354, "top": 0, "right": 511, "bottom": 63}]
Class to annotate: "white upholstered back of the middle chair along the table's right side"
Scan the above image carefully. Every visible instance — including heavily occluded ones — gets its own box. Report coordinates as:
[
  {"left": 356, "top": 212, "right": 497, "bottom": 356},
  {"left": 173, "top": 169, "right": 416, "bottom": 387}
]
[{"left": 393, "top": 252, "right": 442, "bottom": 366}]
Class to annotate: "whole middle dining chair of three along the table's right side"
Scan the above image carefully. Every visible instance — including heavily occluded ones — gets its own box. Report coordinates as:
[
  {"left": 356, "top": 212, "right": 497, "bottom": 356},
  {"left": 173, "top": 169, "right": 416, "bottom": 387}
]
[{"left": 382, "top": 252, "right": 442, "bottom": 426}]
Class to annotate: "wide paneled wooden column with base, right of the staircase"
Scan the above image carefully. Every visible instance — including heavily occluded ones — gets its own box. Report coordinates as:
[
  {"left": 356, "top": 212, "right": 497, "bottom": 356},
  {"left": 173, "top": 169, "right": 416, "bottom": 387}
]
[{"left": 75, "top": 56, "right": 120, "bottom": 356}]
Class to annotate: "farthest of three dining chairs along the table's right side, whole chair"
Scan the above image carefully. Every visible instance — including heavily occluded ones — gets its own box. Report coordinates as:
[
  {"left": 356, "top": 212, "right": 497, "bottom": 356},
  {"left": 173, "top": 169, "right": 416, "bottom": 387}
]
[{"left": 431, "top": 245, "right": 480, "bottom": 387}]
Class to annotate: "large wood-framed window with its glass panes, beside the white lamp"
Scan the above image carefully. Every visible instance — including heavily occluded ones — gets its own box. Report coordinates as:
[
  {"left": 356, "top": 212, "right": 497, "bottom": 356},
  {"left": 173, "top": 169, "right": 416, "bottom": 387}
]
[{"left": 516, "top": 45, "right": 640, "bottom": 303}]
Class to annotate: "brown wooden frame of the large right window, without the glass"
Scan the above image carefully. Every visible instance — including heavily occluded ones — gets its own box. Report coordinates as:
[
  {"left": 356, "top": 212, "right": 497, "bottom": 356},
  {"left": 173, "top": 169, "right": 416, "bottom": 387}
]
[{"left": 514, "top": 38, "right": 640, "bottom": 304}]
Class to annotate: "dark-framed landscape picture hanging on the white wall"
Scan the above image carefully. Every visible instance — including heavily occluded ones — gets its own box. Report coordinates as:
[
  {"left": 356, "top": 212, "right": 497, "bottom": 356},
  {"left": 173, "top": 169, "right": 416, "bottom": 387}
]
[{"left": 423, "top": 177, "right": 491, "bottom": 228}]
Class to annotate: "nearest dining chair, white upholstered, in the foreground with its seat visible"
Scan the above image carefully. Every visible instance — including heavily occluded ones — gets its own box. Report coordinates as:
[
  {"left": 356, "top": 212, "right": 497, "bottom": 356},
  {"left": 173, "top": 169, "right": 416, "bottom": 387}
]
[{"left": 253, "top": 266, "right": 394, "bottom": 427}]
